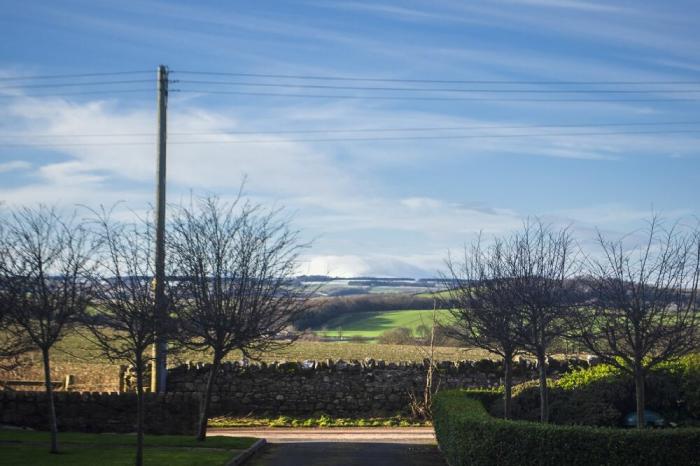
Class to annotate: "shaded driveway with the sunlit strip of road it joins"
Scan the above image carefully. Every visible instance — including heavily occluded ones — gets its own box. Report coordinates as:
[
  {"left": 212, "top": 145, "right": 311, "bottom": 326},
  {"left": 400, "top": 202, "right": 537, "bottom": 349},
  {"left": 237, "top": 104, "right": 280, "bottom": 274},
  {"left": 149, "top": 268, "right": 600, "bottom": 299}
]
[{"left": 209, "top": 428, "right": 446, "bottom": 466}]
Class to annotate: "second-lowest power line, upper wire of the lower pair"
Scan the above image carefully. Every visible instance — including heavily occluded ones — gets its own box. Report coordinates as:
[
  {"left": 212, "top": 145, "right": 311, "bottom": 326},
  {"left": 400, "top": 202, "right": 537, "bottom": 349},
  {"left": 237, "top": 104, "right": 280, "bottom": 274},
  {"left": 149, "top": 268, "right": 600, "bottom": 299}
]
[{"left": 5, "top": 121, "right": 700, "bottom": 138}]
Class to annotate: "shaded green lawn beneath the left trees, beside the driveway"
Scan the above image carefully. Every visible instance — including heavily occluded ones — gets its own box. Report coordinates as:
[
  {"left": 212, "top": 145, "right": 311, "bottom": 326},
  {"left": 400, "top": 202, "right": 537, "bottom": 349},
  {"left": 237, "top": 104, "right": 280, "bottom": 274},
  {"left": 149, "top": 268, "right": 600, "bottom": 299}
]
[{"left": 0, "top": 429, "right": 255, "bottom": 466}]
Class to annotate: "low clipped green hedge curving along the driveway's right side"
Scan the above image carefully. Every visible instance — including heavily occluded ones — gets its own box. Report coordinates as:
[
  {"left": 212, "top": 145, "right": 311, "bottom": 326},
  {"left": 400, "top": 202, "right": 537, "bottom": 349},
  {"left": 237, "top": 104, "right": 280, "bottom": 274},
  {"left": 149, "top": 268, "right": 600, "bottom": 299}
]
[{"left": 433, "top": 390, "right": 700, "bottom": 466}]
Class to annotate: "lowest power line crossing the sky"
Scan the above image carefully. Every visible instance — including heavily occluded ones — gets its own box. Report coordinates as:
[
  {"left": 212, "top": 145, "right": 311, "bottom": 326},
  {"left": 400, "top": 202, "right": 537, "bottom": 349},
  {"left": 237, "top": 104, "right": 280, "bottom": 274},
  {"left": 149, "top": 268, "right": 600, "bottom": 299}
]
[{"left": 0, "top": 129, "right": 700, "bottom": 148}]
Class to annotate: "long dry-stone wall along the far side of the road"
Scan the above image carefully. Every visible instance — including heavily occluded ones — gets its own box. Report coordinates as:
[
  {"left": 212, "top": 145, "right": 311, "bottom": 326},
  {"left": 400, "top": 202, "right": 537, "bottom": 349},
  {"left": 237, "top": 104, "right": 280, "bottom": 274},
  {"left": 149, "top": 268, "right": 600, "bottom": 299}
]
[{"left": 167, "top": 359, "right": 584, "bottom": 416}]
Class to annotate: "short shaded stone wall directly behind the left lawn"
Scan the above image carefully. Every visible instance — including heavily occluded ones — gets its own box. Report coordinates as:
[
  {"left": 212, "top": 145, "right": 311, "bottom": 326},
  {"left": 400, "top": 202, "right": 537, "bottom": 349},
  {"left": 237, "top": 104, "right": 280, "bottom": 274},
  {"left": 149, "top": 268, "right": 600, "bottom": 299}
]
[{"left": 0, "top": 391, "right": 199, "bottom": 434}]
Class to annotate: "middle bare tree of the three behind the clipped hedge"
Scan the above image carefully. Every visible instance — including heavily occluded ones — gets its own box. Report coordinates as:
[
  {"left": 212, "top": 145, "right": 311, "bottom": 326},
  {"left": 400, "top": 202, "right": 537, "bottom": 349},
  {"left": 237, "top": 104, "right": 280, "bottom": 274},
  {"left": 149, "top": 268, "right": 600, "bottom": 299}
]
[{"left": 503, "top": 220, "right": 578, "bottom": 422}]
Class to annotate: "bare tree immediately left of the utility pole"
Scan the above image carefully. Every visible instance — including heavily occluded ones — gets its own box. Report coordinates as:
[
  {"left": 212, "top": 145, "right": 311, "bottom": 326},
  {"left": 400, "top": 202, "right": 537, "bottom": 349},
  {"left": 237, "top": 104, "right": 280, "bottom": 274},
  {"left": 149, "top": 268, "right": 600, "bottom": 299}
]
[{"left": 84, "top": 208, "right": 174, "bottom": 465}]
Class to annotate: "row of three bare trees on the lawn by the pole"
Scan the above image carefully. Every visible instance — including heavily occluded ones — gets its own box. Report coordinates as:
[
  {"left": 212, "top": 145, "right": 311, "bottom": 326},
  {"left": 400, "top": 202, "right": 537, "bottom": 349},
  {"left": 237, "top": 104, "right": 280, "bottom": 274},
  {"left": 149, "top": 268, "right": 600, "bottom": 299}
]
[{"left": 0, "top": 197, "right": 309, "bottom": 464}]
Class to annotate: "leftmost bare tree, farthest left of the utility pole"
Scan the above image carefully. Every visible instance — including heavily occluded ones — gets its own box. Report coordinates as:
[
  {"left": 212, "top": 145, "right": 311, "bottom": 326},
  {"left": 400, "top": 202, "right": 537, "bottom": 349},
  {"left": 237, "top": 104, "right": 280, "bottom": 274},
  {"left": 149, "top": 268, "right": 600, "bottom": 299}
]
[{"left": 0, "top": 205, "right": 92, "bottom": 453}]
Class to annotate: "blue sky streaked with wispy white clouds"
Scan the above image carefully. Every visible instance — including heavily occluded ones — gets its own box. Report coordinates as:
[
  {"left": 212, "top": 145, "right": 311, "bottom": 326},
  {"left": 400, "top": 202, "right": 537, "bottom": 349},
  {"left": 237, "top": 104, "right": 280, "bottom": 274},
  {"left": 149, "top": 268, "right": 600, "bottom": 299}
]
[{"left": 0, "top": 0, "right": 700, "bottom": 277}]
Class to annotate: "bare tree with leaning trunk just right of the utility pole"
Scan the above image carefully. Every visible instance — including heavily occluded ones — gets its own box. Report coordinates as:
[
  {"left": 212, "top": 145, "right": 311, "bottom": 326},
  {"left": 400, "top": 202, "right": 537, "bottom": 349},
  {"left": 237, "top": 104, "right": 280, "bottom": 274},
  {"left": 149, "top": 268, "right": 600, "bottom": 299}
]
[{"left": 169, "top": 197, "right": 309, "bottom": 440}]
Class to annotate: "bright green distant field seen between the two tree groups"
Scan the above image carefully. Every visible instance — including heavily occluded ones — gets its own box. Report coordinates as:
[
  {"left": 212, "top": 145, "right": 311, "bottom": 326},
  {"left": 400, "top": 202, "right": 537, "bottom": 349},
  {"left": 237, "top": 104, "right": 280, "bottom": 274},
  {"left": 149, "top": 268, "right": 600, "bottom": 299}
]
[{"left": 317, "top": 309, "right": 452, "bottom": 339}]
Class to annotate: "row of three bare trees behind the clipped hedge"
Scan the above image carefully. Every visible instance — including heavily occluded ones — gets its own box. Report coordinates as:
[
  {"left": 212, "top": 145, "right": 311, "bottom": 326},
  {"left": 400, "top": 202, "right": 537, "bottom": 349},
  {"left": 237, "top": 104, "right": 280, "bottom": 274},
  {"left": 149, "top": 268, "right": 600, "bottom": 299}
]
[{"left": 446, "top": 217, "right": 700, "bottom": 427}]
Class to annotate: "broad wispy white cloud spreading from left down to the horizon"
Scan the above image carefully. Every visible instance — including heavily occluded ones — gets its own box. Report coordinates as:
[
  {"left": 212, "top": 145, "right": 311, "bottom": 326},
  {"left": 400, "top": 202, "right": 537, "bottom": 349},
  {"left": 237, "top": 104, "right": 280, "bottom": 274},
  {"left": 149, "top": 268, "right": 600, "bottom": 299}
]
[{"left": 0, "top": 80, "right": 697, "bottom": 276}]
